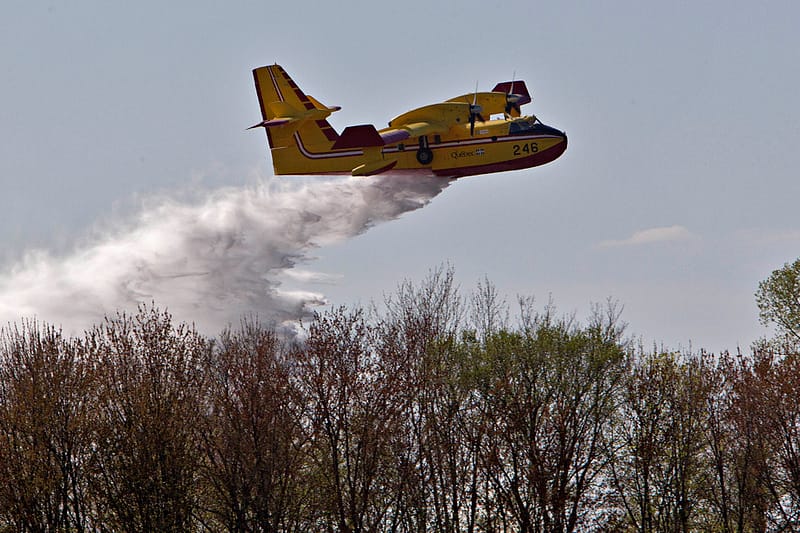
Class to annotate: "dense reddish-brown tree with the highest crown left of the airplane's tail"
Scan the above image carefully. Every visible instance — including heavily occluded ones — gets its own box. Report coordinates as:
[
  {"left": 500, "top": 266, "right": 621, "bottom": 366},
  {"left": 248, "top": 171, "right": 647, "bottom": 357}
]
[{"left": 86, "top": 306, "right": 207, "bottom": 531}]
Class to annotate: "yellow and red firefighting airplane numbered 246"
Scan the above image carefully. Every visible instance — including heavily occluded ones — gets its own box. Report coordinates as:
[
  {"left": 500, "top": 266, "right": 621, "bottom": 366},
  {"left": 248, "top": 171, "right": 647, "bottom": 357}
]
[{"left": 248, "top": 65, "right": 567, "bottom": 178}]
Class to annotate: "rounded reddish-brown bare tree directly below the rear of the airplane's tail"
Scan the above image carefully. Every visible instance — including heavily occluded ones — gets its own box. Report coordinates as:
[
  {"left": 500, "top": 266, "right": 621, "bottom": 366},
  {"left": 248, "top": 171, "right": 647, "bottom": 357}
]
[{"left": 202, "top": 322, "right": 314, "bottom": 533}]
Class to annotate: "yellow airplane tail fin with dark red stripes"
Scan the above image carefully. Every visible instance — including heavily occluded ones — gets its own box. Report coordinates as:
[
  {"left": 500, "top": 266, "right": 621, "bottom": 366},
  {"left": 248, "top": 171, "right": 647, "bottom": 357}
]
[{"left": 252, "top": 65, "right": 340, "bottom": 160}]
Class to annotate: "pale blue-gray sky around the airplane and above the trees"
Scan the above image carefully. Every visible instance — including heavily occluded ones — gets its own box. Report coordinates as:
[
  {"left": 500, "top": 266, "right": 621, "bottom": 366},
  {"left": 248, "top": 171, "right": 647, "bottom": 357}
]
[{"left": 0, "top": 0, "right": 800, "bottom": 351}]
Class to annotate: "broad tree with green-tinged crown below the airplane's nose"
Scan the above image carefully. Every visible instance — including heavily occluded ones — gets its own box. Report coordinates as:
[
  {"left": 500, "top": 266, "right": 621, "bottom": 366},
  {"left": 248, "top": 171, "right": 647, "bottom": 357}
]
[{"left": 478, "top": 310, "right": 625, "bottom": 532}]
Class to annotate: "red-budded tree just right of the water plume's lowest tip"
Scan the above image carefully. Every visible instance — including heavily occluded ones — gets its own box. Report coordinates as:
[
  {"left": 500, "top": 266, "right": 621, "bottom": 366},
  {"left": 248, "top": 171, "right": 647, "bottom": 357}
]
[{"left": 295, "top": 308, "right": 403, "bottom": 533}]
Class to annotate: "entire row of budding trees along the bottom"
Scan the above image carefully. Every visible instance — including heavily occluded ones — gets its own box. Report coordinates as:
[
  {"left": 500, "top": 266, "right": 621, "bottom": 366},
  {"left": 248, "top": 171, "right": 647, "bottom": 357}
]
[{"left": 0, "top": 269, "right": 800, "bottom": 532}]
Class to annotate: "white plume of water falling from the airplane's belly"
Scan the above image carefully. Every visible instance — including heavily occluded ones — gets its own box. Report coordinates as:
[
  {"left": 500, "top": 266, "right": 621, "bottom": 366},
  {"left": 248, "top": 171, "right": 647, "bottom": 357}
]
[{"left": 0, "top": 175, "right": 448, "bottom": 334}]
